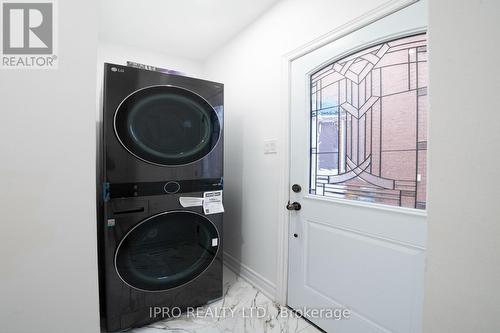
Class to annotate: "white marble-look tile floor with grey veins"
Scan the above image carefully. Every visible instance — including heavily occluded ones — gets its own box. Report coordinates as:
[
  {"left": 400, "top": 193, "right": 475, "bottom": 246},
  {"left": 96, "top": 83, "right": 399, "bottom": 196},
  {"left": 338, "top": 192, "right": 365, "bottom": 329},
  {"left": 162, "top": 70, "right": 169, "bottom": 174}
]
[{"left": 130, "top": 267, "right": 321, "bottom": 333}]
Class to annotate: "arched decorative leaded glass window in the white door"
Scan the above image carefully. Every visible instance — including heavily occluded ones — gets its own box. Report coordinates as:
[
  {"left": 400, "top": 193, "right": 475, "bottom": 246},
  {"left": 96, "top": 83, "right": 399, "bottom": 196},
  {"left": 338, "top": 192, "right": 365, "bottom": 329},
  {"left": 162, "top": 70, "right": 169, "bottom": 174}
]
[{"left": 310, "top": 34, "right": 427, "bottom": 209}]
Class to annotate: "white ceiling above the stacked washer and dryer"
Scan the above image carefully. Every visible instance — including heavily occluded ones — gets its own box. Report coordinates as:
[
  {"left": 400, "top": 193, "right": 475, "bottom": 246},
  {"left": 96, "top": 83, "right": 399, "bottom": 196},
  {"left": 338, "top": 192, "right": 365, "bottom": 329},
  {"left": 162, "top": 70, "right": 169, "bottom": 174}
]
[{"left": 100, "top": 0, "right": 279, "bottom": 60}]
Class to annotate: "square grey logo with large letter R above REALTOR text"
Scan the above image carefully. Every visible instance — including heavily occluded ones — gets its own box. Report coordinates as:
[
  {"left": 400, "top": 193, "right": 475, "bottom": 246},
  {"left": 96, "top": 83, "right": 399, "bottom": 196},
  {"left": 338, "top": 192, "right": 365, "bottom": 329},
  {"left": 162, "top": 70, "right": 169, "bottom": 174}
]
[{"left": 3, "top": 2, "right": 53, "bottom": 54}]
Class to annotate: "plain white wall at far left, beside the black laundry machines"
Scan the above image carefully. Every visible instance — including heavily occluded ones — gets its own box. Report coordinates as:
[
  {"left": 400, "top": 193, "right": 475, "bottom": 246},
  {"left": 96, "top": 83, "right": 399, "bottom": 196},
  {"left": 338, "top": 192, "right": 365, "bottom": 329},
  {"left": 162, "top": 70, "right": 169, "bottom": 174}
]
[{"left": 0, "top": 0, "right": 99, "bottom": 333}]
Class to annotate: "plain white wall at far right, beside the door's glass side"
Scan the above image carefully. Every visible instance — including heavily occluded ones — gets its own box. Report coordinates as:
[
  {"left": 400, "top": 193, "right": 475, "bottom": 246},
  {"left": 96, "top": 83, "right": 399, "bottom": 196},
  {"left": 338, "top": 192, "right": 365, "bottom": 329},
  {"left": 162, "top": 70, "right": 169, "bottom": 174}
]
[{"left": 424, "top": 0, "right": 500, "bottom": 333}]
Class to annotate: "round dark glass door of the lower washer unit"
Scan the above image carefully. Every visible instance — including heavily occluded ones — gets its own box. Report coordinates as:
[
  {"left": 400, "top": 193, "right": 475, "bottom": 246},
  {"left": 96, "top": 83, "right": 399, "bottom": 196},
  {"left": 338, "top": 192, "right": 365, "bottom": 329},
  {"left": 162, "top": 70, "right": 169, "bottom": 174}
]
[{"left": 115, "top": 211, "right": 219, "bottom": 291}]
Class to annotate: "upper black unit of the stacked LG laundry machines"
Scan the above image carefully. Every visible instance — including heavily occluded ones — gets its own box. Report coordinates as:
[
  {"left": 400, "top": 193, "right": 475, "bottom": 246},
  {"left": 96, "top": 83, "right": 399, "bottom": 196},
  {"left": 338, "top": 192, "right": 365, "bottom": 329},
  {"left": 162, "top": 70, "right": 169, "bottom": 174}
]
[{"left": 102, "top": 64, "right": 224, "bottom": 183}]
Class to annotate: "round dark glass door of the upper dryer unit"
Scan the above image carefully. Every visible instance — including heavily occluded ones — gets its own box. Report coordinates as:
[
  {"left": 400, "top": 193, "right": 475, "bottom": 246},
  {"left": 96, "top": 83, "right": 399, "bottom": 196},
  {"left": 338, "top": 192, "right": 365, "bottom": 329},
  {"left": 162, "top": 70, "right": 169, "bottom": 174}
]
[{"left": 114, "top": 86, "right": 221, "bottom": 166}]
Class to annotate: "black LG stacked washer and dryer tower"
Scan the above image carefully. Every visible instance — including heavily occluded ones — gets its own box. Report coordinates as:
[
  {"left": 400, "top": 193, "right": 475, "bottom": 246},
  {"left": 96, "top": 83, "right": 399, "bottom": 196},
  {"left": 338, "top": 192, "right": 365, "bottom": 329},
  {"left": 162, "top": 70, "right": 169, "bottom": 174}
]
[{"left": 98, "top": 64, "right": 223, "bottom": 332}]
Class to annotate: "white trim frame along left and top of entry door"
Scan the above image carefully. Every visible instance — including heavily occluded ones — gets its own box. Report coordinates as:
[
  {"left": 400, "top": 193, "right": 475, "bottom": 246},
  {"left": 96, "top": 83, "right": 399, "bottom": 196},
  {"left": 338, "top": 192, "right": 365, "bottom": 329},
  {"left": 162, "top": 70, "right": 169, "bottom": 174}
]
[{"left": 275, "top": 0, "right": 419, "bottom": 305}]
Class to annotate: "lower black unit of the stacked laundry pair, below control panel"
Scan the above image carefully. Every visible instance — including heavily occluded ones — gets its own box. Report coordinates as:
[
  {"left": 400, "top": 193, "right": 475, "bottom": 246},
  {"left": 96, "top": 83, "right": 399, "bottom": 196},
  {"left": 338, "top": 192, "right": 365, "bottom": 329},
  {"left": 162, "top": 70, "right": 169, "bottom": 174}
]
[{"left": 99, "top": 192, "right": 223, "bottom": 332}]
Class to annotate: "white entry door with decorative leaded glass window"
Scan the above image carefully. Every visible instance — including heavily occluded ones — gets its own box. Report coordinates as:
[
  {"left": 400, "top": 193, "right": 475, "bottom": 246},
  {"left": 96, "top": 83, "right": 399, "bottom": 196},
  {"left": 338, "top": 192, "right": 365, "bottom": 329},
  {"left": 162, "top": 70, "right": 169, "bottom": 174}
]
[{"left": 288, "top": 1, "right": 427, "bottom": 333}]
